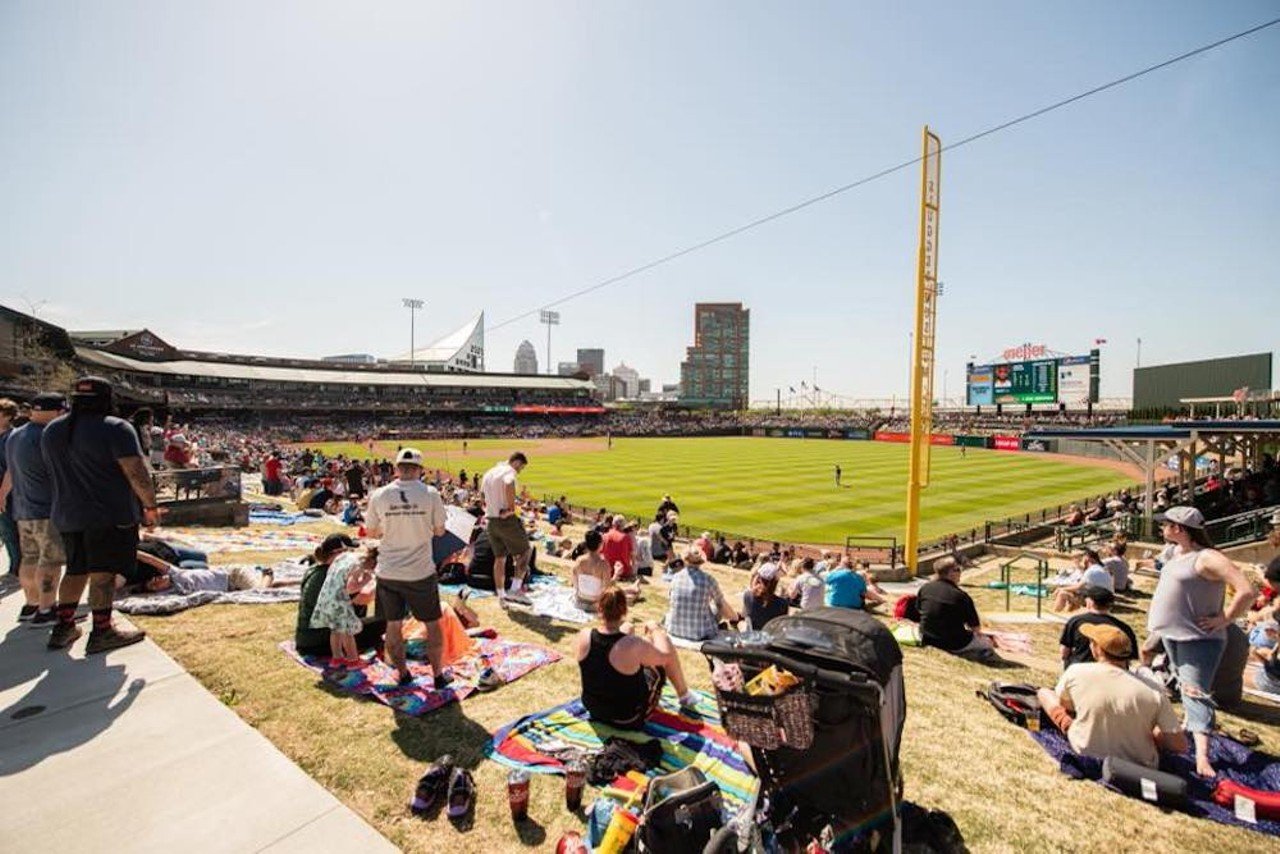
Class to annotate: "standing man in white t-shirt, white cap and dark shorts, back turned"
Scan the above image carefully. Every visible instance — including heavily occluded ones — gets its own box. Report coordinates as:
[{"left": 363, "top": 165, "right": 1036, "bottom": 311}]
[{"left": 365, "top": 448, "right": 449, "bottom": 690}]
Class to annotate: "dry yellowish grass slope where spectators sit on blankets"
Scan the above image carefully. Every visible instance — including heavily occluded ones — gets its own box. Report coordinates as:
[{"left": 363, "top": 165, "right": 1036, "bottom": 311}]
[{"left": 136, "top": 522, "right": 1280, "bottom": 853}]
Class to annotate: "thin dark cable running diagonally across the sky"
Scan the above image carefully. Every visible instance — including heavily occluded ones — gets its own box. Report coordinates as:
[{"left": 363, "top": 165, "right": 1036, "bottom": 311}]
[{"left": 489, "top": 18, "right": 1280, "bottom": 332}]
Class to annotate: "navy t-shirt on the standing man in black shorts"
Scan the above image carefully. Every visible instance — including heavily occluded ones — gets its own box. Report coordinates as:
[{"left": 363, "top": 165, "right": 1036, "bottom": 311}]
[{"left": 40, "top": 412, "right": 142, "bottom": 534}]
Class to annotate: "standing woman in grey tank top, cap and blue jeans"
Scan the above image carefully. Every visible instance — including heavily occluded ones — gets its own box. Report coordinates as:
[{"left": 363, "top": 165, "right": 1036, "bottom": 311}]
[{"left": 1147, "top": 507, "right": 1257, "bottom": 777}]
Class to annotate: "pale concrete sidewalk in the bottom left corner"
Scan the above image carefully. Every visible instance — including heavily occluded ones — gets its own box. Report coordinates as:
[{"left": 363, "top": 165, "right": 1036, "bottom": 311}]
[{"left": 0, "top": 581, "right": 397, "bottom": 854}]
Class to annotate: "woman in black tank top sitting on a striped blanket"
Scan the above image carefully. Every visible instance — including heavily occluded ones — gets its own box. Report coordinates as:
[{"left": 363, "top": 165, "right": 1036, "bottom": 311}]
[{"left": 577, "top": 586, "right": 696, "bottom": 729}]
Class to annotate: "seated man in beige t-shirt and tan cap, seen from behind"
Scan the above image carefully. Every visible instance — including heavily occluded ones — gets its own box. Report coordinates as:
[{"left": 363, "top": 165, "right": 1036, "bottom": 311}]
[{"left": 1037, "top": 624, "right": 1187, "bottom": 768}]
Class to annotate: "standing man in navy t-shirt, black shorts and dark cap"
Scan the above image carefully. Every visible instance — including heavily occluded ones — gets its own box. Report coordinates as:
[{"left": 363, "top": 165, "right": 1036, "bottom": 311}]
[{"left": 40, "top": 376, "right": 159, "bottom": 654}]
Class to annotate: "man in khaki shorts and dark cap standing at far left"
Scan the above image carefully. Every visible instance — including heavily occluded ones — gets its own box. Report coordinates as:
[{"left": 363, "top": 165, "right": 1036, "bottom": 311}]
[{"left": 0, "top": 393, "right": 67, "bottom": 626}]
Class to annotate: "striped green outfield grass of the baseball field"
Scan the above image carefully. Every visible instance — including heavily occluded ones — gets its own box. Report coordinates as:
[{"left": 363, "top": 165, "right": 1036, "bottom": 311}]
[{"left": 304, "top": 437, "right": 1133, "bottom": 544}]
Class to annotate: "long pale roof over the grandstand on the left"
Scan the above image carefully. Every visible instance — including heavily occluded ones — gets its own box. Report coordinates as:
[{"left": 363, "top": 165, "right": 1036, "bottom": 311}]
[{"left": 76, "top": 347, "right": 593, "bottom": 392}]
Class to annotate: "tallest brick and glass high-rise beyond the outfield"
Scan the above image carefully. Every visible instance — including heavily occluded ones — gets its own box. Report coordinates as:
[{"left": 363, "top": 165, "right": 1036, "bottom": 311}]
[{"left": 680, "top": 302, "right": 751, "bottom": 410}]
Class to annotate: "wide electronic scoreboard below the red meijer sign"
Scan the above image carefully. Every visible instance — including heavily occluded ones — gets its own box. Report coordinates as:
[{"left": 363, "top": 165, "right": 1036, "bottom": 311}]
[{"left": 965, "top": 350, "right": 1100, "bottom": 406}]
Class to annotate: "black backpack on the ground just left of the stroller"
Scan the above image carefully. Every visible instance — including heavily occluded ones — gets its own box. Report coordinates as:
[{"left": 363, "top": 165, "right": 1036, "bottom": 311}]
[{"left": 637, "top": 766, "right": 724, "bottom": 854}]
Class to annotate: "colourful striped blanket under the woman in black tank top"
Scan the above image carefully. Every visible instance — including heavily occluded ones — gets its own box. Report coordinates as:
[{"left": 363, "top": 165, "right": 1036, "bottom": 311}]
[{"left": 485, "top": 685, "right": 760, "bottom": 819}]
